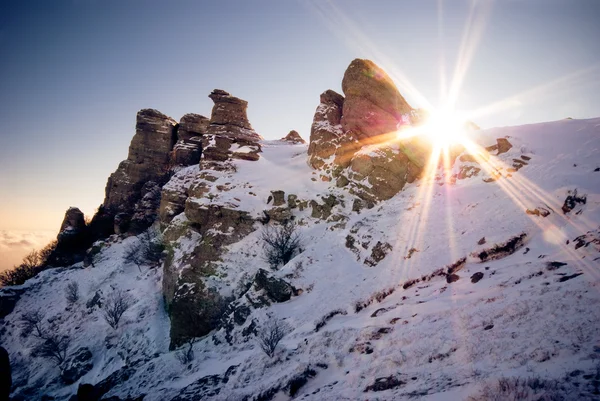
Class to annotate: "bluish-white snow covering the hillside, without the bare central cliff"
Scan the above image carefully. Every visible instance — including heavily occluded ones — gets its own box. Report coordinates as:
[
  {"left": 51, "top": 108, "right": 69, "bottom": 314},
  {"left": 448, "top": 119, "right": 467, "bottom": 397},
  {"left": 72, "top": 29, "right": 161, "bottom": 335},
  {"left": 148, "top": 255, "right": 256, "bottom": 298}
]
[{"left": 2, "top": 118, "right": 600, "bottom": 401}]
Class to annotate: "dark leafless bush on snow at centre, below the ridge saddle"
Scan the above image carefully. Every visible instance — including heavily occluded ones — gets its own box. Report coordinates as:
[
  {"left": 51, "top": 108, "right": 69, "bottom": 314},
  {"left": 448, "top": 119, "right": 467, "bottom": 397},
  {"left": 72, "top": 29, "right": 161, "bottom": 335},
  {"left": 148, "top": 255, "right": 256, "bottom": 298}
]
[{"left": 261, "top": 222, "right": 301, "bottom": 269}]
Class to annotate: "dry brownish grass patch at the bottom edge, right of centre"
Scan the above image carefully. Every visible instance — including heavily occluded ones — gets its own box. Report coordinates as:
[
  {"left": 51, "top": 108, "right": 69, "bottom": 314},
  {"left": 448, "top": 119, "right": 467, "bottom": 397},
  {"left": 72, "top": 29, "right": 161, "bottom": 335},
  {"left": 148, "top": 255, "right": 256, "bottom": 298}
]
[{"left": 467, "top": 377, "right": 569, "bottom": 401}]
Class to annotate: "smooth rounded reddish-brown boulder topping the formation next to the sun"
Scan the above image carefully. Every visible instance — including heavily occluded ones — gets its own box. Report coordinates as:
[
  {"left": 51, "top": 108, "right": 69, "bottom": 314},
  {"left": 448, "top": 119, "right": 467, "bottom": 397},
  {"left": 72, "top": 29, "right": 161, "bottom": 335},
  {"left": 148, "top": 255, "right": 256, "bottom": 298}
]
[{"left": 341, "top": 59, "right": 412, "bottom": 140}]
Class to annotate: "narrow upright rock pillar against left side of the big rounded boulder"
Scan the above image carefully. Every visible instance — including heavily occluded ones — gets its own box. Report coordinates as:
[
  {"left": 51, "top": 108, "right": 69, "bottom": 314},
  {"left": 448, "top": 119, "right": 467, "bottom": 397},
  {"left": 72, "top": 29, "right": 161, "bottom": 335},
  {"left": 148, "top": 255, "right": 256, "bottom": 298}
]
[{"left": 308, "top": 90, "right": 344, "bottom": 169}]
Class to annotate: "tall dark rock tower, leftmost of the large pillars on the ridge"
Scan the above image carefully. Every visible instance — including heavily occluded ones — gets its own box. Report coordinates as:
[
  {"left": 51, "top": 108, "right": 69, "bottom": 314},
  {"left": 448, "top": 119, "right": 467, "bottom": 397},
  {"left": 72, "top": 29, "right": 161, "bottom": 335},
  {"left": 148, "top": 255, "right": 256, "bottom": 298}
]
[{"left": 103, "top": 109, "right": 177, "bottom": 213}]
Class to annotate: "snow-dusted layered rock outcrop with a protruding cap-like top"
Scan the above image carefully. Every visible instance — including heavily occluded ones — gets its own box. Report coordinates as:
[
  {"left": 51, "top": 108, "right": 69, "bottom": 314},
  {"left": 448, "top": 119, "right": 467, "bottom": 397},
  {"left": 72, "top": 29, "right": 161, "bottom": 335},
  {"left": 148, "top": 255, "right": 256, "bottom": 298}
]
[{"left": 202, "top": 89, "right": 262, "bottom": 168}]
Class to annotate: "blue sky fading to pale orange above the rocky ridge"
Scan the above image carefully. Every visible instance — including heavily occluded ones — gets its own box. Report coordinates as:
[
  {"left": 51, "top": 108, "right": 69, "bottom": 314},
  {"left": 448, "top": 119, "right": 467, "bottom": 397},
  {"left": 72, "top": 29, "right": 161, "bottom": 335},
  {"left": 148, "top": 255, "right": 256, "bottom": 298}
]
[{"left": 0, "top": 0, "right": 600, "bottom": 270}]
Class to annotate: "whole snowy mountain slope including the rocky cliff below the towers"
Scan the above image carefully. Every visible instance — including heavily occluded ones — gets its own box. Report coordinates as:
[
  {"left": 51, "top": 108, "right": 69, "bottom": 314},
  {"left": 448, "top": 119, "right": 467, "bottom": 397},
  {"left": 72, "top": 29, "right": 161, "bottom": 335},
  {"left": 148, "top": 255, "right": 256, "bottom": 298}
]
[{"left": 1, "top": 57, "right": 600, "bottom": 401}]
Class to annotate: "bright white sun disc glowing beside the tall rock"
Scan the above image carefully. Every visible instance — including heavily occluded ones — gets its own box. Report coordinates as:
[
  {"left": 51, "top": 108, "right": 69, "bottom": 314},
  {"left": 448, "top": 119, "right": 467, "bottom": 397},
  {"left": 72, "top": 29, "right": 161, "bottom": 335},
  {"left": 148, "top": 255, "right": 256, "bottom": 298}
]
[{"left": 423, "top": 110, "right": 466, "bottom": 148}]
